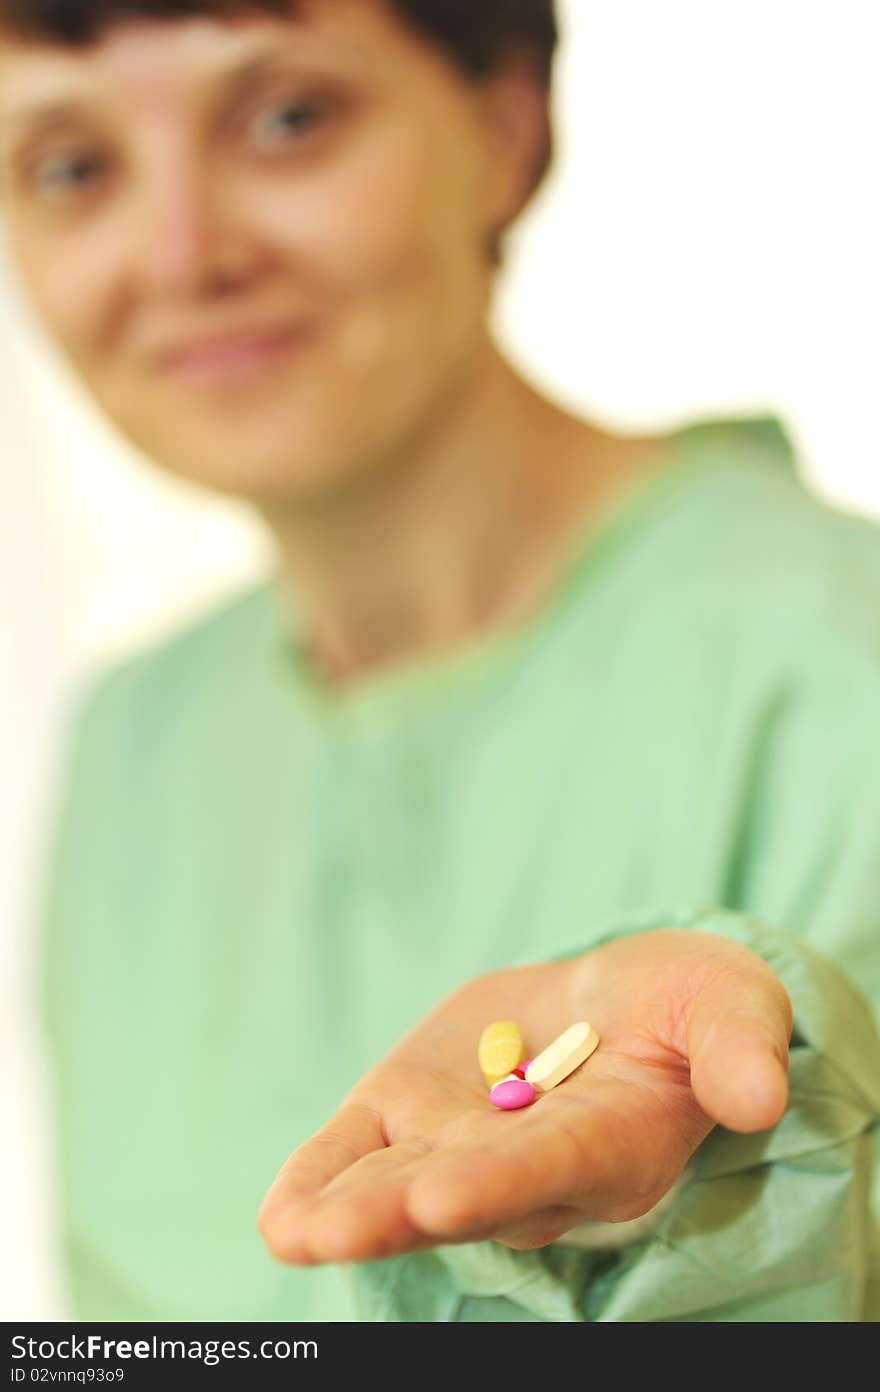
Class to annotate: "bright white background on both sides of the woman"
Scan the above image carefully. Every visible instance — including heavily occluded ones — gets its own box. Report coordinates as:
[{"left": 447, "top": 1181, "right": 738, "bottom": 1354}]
[{"left": 0, "top": 0, "right": 880, "bottom": 1320}]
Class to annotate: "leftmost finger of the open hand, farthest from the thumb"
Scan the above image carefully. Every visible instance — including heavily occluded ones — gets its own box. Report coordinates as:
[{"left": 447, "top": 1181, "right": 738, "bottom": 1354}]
[{"left": 258, "top": 1102, "right": 386, "bottom": 1264}]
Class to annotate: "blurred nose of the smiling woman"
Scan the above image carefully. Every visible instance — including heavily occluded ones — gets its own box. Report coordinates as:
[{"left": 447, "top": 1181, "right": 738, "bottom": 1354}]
[{"left": 136, "top": 151, "right": 265, "bottom": 294}]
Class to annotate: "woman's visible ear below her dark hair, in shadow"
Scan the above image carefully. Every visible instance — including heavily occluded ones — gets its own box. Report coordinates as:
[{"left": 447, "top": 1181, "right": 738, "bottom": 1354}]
[{"left": 479, "top": 54, "right": 550, "bottom": 244}]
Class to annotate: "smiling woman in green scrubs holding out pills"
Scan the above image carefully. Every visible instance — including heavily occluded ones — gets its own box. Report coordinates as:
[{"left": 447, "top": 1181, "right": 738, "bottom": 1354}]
[{"left": 0, "top": 0, "right": 880, "bottom": 1320}]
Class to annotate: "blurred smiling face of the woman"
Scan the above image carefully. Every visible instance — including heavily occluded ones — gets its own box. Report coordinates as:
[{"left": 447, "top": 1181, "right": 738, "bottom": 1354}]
[{"left": 0, "top": 0, "right": 524, "bottom": 504}]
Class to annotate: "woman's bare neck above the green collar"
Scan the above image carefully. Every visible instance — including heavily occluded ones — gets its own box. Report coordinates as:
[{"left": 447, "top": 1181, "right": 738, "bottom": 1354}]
[{"left": 254, "top": 338, "right": 660, "bottom": 685}]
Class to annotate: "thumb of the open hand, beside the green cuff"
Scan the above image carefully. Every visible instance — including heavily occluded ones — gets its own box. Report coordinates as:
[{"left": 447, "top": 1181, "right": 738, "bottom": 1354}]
[{"left": 688, "top": 958, "right": 792, "bottom": 1132}]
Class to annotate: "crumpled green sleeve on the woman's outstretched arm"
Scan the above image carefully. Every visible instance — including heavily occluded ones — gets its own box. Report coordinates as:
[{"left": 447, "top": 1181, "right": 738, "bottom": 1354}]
[{"left": 345, "top": 643, "right": 880, "bottom": 1322}]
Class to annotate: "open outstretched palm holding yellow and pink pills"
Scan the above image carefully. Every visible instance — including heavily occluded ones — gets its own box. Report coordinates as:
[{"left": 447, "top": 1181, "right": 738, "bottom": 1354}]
[{"left": 259, "top": 928, "right": 792, "bottom": 1265}]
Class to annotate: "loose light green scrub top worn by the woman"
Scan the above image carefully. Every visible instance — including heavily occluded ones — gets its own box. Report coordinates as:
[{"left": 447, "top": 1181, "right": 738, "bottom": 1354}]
[{"left": 40, "top": 418, "right": 880, "bottom": 1321}]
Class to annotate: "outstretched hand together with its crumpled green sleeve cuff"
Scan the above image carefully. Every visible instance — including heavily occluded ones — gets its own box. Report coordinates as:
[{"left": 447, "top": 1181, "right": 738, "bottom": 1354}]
[{"left": 262, "top": 913, "right": 880, "bottom": 1320}]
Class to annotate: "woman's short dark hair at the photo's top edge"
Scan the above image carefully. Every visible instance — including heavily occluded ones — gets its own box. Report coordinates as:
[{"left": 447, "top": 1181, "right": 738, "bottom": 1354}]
[{"left": 0, "top": 0, "right": 558, "bottom": 85}]
